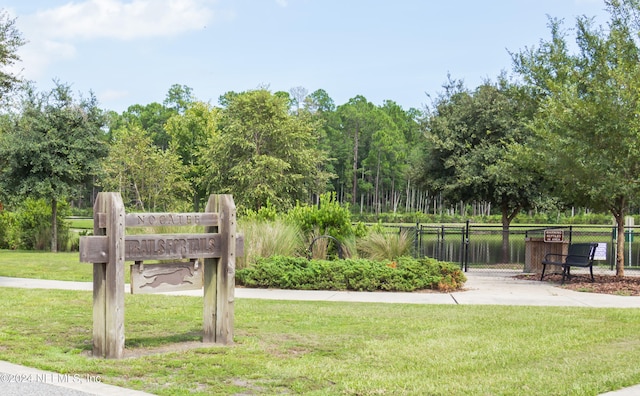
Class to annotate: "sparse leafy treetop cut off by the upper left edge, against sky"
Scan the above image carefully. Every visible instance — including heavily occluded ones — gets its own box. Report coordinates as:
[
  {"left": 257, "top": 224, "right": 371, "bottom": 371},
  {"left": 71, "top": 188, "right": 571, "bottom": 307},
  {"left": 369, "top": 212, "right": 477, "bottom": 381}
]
[{"left": 0, "top": 10, "right": 25, "bottom": 102}]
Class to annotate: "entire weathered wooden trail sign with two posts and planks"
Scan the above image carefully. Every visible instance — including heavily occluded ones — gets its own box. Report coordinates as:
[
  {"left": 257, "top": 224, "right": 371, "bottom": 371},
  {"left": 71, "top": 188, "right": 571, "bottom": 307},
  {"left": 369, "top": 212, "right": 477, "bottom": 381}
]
[{"left": 80, "top": 192, "right": 243, "bottom": 359}]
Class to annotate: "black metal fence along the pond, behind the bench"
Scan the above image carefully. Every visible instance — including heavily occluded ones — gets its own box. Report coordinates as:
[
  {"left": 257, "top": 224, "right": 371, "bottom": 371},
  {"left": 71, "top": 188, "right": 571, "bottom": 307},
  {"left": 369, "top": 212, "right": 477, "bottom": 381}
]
[{"left": 384, "top": 223, "right": 640, "bottom": 271}]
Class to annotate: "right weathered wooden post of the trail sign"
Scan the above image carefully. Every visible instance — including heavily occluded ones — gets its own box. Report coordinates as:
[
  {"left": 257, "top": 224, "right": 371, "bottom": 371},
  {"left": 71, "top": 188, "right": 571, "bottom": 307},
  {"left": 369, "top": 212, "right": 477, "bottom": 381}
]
[{"left": 202, "top": 194, "right": 236, "bottom": 345}]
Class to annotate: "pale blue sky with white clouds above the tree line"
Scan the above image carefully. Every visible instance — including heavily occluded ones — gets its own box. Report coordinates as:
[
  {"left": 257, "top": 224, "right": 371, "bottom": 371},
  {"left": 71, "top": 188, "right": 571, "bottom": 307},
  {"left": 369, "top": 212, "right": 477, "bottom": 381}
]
[{"left": 0, "top": 0, "right": 608, "bottom": 113}]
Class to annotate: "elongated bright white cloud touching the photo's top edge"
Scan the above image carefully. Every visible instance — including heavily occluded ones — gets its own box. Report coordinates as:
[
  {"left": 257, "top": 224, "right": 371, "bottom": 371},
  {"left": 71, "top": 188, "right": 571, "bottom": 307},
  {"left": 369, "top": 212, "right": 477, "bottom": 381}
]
[{"left": 29, "top": 0, "right": 213, "bottom": 40}]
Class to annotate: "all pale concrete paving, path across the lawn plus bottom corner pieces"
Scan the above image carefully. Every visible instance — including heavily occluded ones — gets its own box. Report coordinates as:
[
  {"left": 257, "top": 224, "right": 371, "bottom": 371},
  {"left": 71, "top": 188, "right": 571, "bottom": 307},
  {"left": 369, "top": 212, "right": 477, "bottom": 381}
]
[{"left": 0, "top": 270, "right": 640, "bottom": 396}]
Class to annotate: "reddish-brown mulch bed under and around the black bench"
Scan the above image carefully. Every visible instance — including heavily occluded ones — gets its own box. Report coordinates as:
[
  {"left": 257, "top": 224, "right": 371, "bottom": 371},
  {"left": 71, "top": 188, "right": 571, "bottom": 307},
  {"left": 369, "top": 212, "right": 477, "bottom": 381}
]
[{"left": 516, "top": 274, "right": 640, "bottom": 296}]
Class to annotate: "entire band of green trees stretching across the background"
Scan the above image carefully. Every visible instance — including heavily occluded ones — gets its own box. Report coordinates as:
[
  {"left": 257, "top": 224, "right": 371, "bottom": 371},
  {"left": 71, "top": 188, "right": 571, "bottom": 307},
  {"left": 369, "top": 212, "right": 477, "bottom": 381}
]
[{"left": 0, "top": 0, "right": 640, "bottom": 273}]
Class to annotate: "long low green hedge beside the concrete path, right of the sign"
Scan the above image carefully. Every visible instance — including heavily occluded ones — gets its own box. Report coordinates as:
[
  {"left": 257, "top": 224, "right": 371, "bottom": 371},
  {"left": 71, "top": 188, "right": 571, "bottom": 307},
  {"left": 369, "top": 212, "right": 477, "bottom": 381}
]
[{"left": 236, "top": 256, "right": 466, "bottom": 292}]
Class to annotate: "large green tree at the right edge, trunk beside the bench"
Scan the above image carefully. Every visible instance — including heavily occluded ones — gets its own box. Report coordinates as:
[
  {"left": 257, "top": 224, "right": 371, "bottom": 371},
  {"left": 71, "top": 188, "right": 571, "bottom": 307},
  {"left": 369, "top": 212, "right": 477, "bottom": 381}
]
[{"left": 514, "top": 0, "right": 640, "bottom": 276}]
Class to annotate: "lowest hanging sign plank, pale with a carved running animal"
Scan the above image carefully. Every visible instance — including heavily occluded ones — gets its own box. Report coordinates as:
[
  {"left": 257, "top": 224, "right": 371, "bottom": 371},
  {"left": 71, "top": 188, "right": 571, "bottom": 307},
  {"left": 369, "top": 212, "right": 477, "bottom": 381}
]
[{"left": 131, "top": 260, "right": 203, "bottom": 294}]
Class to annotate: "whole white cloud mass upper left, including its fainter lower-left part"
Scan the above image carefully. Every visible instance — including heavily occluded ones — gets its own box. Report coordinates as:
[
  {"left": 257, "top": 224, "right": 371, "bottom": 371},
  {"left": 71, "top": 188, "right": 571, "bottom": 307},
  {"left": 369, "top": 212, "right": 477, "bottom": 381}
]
[{"left": 12, "top": 0, "right": 215, "bottom": 79}]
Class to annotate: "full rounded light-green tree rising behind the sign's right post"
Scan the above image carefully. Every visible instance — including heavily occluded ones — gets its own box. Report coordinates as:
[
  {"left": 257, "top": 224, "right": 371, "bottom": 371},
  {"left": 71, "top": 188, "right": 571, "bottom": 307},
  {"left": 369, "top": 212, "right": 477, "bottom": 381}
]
[{"left": 202, "top": 89, "right": 329, "bottom": 210}]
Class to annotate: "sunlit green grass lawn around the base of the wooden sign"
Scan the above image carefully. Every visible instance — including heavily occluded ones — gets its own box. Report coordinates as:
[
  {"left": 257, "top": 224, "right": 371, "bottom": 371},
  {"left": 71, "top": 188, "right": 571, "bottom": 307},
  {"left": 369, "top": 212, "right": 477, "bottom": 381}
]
[{"left": 0, "top": 251, "right": 640, "bottom": 395}]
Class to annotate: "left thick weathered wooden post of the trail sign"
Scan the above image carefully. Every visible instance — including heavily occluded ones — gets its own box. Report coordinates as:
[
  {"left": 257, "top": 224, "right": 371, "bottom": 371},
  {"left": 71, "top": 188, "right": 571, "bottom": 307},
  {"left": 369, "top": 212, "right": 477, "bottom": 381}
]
[{"left": 93, "top": 192, "right": 125, "bottom": 359}]
